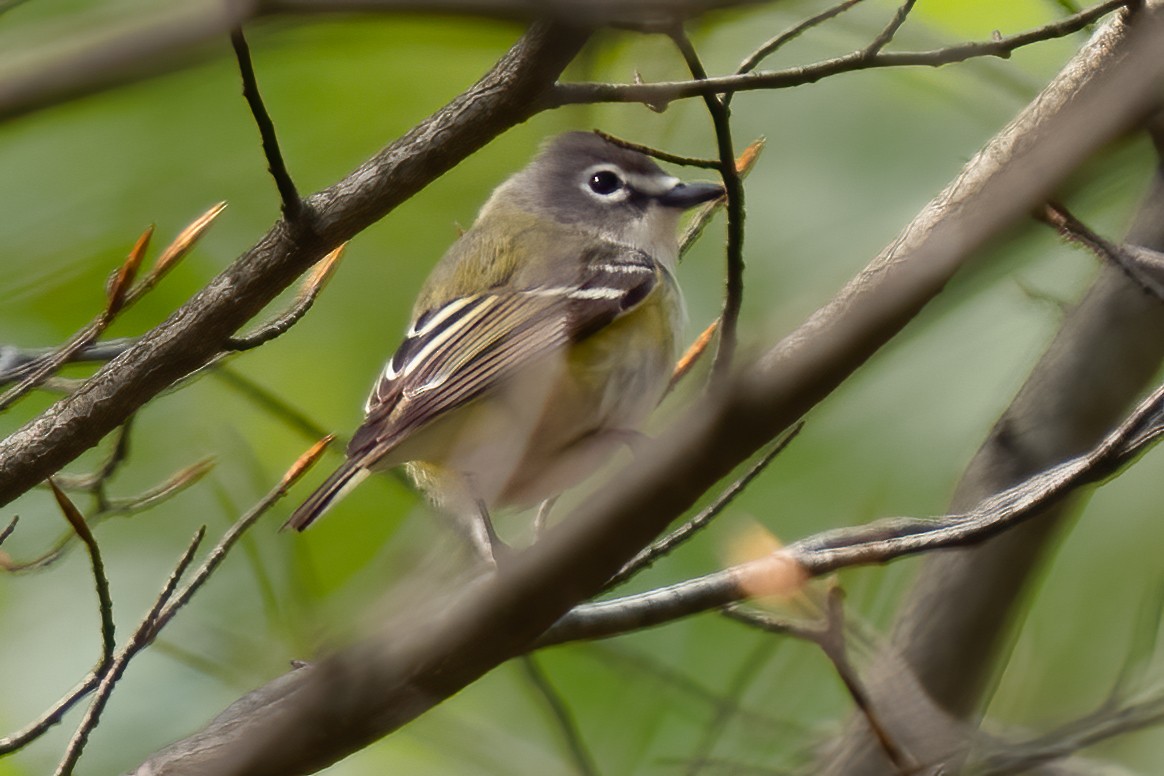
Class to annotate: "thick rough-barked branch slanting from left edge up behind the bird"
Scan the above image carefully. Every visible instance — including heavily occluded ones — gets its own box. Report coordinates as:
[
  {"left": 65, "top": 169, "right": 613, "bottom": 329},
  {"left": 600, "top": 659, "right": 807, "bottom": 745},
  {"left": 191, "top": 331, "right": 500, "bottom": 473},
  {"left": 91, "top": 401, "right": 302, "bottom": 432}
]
[{"left": 0, "top": 19, "right": 587, "bottom": 504}]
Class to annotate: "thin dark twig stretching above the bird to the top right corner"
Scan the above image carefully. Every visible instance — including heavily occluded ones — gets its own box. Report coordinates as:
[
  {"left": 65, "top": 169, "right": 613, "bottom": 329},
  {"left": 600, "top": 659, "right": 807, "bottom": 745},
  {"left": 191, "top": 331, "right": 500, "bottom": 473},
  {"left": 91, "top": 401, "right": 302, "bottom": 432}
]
[{"left": 545, "top": 0, "right": 1136, "bottom": 107}]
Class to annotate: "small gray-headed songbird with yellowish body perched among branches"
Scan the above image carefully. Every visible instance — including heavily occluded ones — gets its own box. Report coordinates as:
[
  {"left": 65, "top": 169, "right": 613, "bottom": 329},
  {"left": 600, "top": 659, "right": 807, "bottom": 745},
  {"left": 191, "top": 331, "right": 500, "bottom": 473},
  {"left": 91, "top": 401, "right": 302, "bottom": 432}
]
[{"left": 284, "top": 131, "right": 724, "bottom": 557}]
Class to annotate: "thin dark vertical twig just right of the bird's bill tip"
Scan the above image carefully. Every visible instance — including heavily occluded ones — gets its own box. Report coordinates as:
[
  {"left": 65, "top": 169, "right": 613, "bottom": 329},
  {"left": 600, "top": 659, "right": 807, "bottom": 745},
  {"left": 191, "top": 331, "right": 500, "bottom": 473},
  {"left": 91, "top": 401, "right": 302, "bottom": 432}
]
[{"left": 672, "top": 28, "right": 744, "bottom": 383}]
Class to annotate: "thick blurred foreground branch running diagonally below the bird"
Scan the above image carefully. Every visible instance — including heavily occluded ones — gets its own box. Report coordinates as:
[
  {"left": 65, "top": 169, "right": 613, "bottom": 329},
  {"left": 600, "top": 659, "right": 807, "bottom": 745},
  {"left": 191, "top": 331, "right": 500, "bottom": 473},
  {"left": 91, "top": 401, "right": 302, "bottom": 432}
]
[{"left": 137, "top": 7, "right": 1164, "bottom": 776}]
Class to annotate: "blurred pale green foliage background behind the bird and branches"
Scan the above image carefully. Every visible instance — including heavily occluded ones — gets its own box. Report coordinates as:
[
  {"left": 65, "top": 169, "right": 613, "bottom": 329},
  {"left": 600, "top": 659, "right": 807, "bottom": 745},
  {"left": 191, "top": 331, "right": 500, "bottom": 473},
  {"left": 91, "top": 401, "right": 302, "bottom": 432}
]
[{"left": 0, "top": 0, "right": 1164, "bottom": 776}]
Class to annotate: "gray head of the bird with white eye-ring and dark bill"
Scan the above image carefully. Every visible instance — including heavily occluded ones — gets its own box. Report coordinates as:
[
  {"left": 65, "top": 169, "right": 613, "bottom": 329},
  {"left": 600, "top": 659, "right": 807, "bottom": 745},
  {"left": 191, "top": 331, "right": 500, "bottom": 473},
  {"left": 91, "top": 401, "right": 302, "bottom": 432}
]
[{"left": 485, "top": 131, "right": 723, "bottom": 259}]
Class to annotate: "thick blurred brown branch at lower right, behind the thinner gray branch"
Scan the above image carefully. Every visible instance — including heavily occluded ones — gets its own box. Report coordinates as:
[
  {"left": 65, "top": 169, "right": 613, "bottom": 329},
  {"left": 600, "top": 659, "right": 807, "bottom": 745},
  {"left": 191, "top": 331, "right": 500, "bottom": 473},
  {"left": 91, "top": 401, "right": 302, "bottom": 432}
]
[{"left": 826, "top": 62, "right": 1164, "bottom": 776}]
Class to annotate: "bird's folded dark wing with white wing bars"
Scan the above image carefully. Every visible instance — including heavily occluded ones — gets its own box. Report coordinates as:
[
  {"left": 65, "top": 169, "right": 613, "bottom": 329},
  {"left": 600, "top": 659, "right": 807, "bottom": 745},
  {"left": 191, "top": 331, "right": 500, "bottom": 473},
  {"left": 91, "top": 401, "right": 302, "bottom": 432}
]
[{"left": 348, "top": 245, "right": 662, "bottom": 467}]
